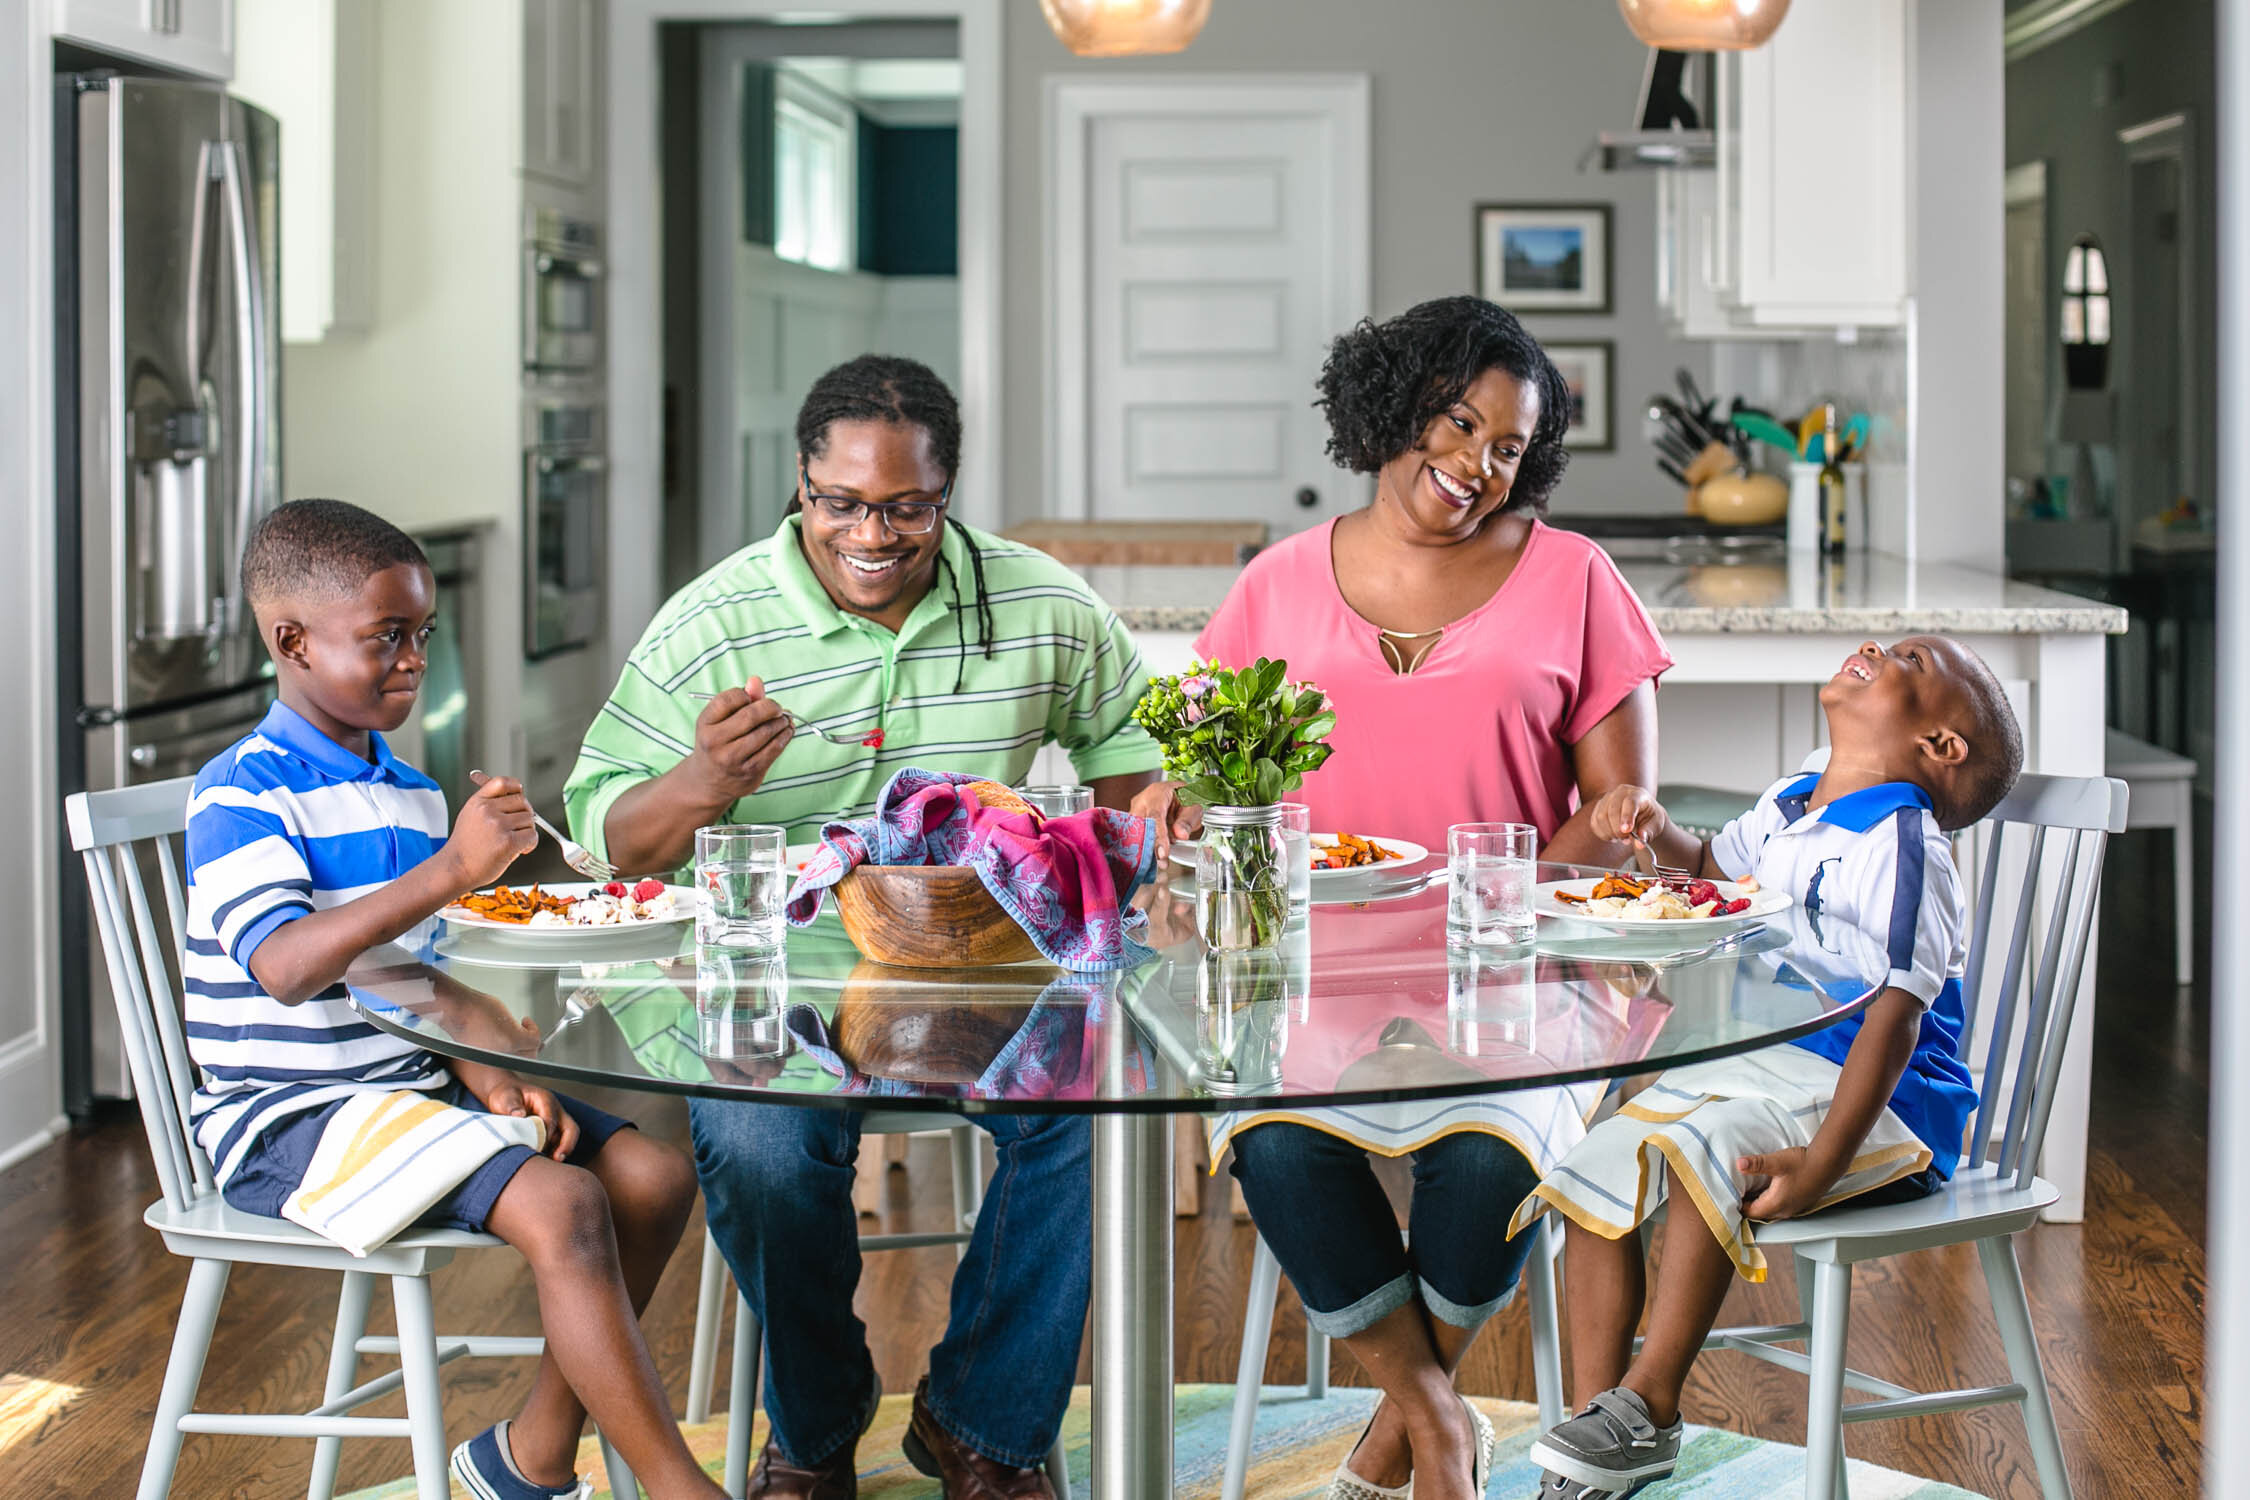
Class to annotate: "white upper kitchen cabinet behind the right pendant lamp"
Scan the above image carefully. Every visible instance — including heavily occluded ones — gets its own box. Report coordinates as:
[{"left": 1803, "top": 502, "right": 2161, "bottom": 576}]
[{"left": 1712, "top": 0, "right": 1910, "bottom": 328}]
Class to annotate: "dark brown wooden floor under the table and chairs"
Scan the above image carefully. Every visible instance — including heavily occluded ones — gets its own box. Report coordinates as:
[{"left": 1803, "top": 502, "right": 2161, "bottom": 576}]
[{"left": 0, "top": 834, "right": 2210, "bottom": 1500}]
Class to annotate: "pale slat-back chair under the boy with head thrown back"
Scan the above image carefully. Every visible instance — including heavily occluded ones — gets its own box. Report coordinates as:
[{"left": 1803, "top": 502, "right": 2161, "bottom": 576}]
[{"left": 1703, "top": 776, "right": 2126, "bottom": 1500}]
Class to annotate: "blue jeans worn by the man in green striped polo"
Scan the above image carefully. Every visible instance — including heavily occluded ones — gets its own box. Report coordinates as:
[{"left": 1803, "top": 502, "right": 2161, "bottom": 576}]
[{"left": 689, "top": 1100, "right": 1094, "bottom": 1469}]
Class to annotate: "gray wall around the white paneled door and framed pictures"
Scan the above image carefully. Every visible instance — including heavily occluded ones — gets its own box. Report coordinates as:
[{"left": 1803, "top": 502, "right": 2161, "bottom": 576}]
[{"left": 1003, "top": 0, "right": 1708, "bottom": 519}]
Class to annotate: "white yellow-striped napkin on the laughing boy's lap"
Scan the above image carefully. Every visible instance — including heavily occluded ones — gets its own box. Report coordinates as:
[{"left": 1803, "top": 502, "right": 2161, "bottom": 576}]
[{"left": 1508, "top": 1046, "right": 1931, "bottom": 1282}]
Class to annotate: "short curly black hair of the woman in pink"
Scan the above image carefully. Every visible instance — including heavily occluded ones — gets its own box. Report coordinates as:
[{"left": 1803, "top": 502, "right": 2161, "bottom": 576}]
[{"left": 1312, "top": 297, "right": 1571, "bottom": 515}]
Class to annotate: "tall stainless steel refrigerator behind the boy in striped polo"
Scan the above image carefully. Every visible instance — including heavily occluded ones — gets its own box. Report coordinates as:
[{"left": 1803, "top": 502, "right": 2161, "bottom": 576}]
[{"left": 54, "top": 74, "right": 281, "bottom": 1118}]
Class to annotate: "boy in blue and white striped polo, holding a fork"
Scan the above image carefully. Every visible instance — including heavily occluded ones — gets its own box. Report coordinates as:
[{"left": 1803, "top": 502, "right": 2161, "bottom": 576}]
[{"left": 185, "top": 499, "right": 722, "bottom": 1500}]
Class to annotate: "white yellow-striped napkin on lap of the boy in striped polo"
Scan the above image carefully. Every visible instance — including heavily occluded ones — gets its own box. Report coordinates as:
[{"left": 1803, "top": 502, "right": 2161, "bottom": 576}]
[{"left": 281, "top": 1088, "right": 547, "bottom": 1255}]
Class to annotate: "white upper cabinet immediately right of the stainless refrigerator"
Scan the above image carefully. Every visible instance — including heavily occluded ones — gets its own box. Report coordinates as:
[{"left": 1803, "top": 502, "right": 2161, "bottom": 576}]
[{"left": 234, "top": 0, "right": 378, "bottom": 344}]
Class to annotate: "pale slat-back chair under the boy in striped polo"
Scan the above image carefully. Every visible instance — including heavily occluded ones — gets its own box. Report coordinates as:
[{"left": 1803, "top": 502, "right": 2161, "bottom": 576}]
[{"left": 63, "top": 776, "right": 639, "bottom": 1500}]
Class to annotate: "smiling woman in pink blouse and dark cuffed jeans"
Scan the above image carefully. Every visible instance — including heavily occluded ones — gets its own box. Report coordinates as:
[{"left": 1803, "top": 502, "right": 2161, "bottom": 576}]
[{"left": 1134, "top": 297, "right": 1672, "bottom": 1500}]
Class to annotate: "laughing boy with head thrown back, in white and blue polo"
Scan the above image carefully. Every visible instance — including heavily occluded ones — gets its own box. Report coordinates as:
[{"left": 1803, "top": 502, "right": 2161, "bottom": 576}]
[{"left": 1512, "top": 636, "right": 2023, "bottom": 1500}]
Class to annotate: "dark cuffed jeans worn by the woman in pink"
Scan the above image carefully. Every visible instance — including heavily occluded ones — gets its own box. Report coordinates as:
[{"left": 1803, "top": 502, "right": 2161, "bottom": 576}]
[{"left": 1233, "top": 1120, "right": 1539, "bottom": 1338}]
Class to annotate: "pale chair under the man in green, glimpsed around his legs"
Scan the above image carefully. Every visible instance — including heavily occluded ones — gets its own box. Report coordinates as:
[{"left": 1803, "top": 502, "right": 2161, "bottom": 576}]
[{"left": 686, "top": 1111, "right": 1071, "bottom": 1500}]
